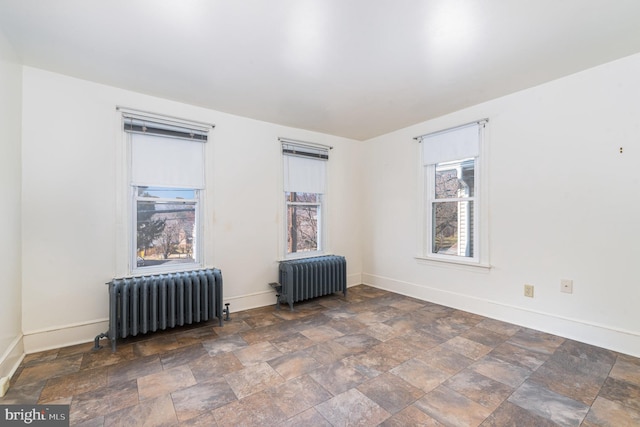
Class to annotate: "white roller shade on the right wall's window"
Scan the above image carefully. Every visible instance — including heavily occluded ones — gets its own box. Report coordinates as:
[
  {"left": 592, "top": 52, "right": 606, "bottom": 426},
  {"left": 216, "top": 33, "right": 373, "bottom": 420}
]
[{"left": 419, "top": 123, "right": 483, "bottom": 165}]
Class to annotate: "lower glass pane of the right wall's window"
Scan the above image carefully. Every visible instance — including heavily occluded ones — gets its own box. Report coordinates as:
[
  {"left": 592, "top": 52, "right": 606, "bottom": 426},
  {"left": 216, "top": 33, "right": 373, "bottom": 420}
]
[{"left": 432, "top": 201, "right": 474, "bottom": 257}]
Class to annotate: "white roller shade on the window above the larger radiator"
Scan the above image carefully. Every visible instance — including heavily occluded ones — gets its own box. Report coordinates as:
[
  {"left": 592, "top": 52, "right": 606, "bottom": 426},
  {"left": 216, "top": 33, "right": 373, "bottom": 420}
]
[{"left": 130, "top": 133, "right": 205, "bottom": 189}]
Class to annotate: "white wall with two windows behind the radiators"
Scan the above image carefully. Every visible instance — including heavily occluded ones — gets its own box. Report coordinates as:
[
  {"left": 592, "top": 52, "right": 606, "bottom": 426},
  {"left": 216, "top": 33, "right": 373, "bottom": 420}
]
[{"left": 22, "top": 67, "right": 362, "bottom": 353}]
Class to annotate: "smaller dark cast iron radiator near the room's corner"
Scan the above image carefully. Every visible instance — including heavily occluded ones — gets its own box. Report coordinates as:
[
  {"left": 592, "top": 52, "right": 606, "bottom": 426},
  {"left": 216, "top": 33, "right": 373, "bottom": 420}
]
[{"left": 276, "top": 255, "right": 347, "bottom": 310}]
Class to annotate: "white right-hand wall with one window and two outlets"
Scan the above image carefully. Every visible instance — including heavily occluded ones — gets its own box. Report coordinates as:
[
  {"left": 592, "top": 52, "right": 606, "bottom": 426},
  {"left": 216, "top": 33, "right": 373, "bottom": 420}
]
[{"left": 363, "top": 55, "right": 640, "bottom": 356}]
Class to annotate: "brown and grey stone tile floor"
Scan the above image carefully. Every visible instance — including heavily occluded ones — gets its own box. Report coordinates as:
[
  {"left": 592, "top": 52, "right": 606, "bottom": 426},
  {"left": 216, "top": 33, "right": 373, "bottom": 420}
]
[{"left": 0, "top": 285, "right": 640, "bottom": 427}]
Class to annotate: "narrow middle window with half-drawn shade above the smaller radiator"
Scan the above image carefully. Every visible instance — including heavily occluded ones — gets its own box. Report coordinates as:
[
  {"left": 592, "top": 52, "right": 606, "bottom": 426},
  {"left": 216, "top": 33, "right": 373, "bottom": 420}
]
[{"left": 280, "top": 139, "right": 329, "bottom": 258}]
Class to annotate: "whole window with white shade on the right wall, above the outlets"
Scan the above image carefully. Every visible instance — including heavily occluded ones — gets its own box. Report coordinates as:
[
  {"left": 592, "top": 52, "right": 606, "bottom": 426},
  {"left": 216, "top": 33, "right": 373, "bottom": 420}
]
[{"left": 418, "top": 121, "right": 488, "bottom": 264}]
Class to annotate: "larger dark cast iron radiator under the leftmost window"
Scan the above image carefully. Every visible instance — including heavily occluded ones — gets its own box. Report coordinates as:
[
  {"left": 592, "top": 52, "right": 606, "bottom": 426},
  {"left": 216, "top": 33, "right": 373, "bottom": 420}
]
[{"left": 95, "top": 268, "right": 223, "bottom": 352}]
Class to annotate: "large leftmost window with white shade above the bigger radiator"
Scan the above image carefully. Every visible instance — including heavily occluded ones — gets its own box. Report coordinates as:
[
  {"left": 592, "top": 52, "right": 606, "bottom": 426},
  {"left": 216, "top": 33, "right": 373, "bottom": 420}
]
[{"left": 123, "top": 112, "right": 210, "bottom": 274}]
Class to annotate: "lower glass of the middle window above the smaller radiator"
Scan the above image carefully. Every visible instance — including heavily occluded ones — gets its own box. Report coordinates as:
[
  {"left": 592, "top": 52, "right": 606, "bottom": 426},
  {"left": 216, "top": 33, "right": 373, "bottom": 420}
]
[{"left": 287, "top": 205, "right": 319, "bottom": 253}]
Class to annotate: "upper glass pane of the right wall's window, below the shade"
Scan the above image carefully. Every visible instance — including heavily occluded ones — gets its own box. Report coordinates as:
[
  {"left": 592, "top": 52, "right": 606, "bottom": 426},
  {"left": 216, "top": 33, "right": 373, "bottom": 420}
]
[{"left": 435, "top": 159, "right": 475, "bottom": 199}]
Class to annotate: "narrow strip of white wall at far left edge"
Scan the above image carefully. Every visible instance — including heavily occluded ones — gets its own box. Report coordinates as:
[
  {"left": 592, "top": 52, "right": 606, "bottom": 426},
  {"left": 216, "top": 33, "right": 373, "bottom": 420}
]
[{"left": 0, "top": 25, "right": 23, "bottom": 388}]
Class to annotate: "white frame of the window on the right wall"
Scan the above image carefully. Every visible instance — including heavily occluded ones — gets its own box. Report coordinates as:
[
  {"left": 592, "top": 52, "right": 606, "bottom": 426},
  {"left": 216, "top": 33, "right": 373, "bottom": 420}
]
[{"left": 415, "top": 119, "right": 491, "bottom": 269}]
